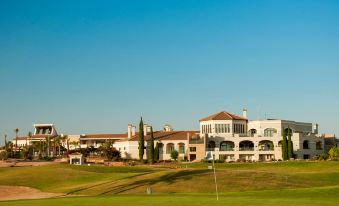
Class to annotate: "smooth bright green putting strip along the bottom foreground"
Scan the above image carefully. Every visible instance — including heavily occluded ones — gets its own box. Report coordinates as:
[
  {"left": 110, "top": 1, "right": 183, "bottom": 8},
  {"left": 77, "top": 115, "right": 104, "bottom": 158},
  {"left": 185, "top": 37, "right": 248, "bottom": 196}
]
[{"left": 0, "top": 188, "right": 339, "bottom": 206}]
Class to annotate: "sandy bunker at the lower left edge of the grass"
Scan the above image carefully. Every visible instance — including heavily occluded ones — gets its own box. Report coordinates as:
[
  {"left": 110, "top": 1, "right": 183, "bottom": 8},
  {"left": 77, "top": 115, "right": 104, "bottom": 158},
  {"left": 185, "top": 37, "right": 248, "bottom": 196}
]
[{"left": 0, "top": 186, "right": 65, "bottom": 201}]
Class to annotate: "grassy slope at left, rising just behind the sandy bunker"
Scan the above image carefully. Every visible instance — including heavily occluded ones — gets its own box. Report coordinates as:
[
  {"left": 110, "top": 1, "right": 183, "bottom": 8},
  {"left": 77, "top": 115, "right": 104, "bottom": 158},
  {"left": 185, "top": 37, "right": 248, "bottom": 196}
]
[{"left": 0, "top": 164, "right": 151, "bottom": 193}]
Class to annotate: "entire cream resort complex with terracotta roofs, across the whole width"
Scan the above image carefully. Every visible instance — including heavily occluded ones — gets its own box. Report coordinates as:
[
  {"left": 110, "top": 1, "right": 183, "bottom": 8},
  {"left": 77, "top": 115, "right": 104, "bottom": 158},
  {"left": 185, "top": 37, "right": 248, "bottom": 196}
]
[{"left": 10, "top": 109, "right": 330, "bottom": 162}]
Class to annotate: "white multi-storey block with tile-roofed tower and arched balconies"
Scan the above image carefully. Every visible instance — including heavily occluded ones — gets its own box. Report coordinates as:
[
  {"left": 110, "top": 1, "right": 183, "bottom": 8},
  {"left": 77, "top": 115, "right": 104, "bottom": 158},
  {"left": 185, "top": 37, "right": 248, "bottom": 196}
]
[{"left": 200, "top": 110, "right": 324, "bottom": 161}]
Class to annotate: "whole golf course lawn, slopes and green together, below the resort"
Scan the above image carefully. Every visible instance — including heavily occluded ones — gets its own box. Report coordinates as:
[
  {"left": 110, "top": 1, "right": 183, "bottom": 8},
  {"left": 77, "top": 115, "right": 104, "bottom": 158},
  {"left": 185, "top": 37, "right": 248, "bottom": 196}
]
[{"left": 0, "top": 162, "right": 339, "bottom": 205}]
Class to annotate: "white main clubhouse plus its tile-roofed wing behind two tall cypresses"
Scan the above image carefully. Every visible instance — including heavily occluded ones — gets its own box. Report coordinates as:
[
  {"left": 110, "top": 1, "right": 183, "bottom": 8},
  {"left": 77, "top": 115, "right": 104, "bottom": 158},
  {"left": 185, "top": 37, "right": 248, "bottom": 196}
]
[{"left": 114, "top": 110, "right": 324, "bottom": 161}]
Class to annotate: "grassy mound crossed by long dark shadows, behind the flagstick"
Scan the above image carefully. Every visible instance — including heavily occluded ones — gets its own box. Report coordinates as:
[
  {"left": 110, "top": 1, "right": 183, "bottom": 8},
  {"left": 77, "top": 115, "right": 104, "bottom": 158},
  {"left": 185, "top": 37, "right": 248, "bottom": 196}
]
[{"left": 67, "top": 162, "right": 339, "bottom": 195}]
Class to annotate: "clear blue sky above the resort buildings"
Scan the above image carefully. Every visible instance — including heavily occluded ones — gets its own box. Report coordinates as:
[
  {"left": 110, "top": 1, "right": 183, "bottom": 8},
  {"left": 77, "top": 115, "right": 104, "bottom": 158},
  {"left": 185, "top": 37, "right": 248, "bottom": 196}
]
[{"left": 0, "top": 0, "right": 339, "bottom": 140}]
